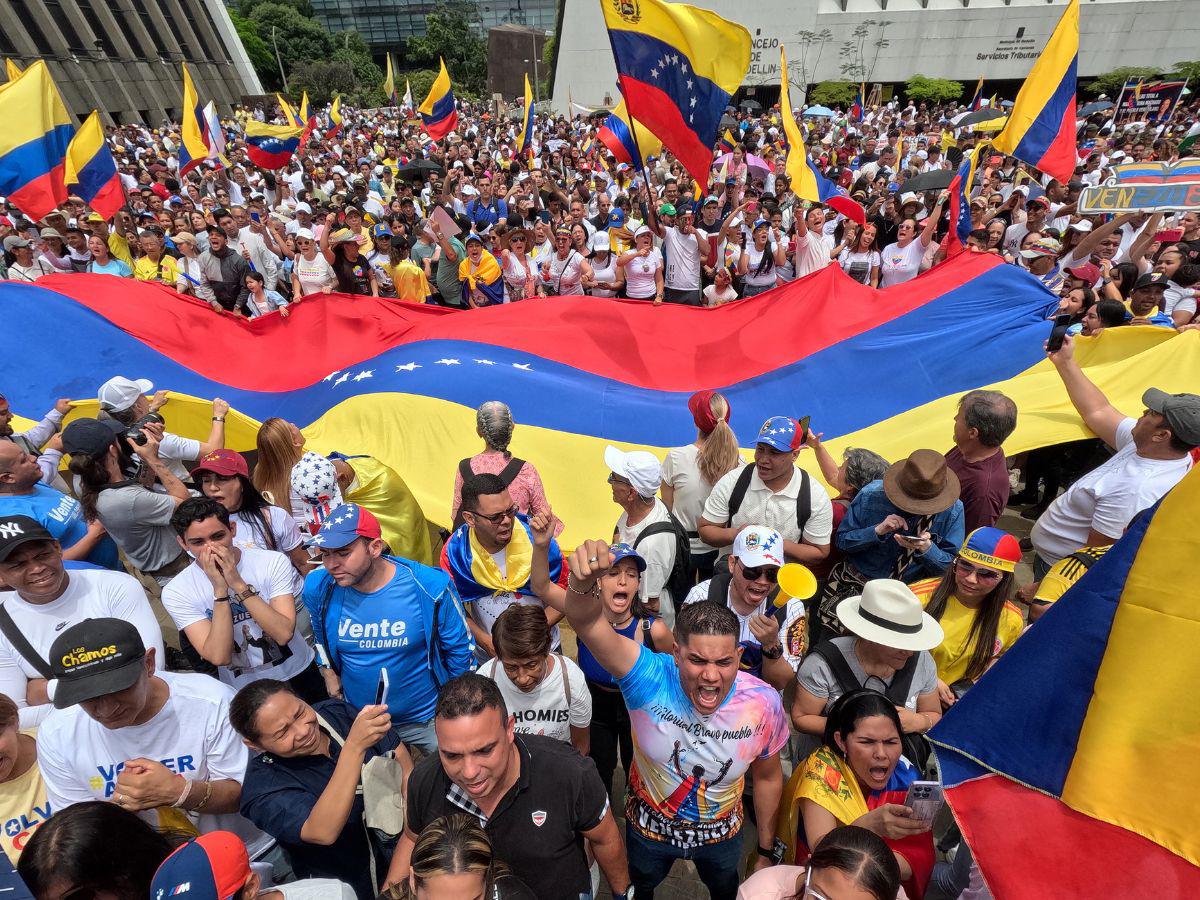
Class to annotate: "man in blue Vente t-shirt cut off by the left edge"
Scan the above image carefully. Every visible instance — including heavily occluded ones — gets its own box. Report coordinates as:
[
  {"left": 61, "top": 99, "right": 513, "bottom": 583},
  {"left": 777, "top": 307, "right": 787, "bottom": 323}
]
[{"left": 0, "top": 440, "right": 121, "bottom": 571}]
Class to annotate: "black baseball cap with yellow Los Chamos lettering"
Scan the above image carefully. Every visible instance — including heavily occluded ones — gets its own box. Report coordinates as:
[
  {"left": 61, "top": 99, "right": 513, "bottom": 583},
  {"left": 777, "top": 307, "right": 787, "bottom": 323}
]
[{"left": 49, "top": 619, "right": 146, "bottom": 709}]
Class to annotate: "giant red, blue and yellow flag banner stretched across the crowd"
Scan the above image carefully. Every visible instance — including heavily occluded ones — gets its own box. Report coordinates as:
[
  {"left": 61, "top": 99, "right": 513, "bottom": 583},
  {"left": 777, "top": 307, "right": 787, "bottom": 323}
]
[{"left": 0, "top": 253, "right": 1200, "bottom": 546}]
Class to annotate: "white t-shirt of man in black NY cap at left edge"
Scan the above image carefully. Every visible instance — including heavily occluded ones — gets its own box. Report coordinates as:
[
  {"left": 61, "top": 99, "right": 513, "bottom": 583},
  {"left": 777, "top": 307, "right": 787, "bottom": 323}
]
[{"left": 0, "top": 569, "right": 166, "bottom": 728}]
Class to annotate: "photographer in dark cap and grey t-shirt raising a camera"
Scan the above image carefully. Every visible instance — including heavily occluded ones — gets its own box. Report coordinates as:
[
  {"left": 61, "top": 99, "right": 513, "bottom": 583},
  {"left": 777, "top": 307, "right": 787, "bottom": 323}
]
[{"left": 62, "top": 419, "right": 191, "bottom": 586}]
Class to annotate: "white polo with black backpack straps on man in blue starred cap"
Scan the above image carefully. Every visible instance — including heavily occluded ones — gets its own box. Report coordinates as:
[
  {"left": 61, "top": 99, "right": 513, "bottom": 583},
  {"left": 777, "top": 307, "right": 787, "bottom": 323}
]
[{"left": 702, "top": 466, "right": 833, "bottom": 558}]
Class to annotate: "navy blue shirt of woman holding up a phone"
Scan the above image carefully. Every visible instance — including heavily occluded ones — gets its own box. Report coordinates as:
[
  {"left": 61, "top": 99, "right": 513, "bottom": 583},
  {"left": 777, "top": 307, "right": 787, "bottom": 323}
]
[{"left": 241, "top": 700, "right": 400, "bottom": 898}]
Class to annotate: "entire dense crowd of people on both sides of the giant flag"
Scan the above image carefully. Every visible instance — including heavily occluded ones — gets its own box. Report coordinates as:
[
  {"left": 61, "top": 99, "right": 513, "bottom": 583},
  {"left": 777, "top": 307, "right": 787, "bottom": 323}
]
[{"left": 0, "top": 79, "right": 1200, "bottom": 900}]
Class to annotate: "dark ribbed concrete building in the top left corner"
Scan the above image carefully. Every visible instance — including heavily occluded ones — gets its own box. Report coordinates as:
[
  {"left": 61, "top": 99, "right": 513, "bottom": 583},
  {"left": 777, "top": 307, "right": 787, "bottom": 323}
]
[{"left": 0, "top": 0, "right": 263, "bottom": 125}]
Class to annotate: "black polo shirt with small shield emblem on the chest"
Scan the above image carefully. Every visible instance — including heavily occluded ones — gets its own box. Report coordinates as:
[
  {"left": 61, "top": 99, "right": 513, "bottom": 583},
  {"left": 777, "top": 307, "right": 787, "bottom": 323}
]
[{"left": 407, "top": 734, "right": 608, "bottom": 900}]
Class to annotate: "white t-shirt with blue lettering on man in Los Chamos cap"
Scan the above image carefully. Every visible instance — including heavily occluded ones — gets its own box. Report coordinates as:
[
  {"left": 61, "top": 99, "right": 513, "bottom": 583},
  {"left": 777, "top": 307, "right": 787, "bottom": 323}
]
[{"left": 37, "top": 672, "right": 275, "bottom": 859}]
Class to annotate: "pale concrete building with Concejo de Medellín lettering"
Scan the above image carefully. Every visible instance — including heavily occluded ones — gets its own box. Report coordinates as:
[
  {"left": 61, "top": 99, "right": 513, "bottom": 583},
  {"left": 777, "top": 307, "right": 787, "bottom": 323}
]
[{"left": 553, "top": 0, "right": 1200, "bottom": 112}]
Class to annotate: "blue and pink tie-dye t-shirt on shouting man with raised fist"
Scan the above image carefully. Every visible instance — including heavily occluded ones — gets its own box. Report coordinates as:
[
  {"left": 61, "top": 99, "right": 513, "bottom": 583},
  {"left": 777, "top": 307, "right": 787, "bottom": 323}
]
[{"left": 619, "top": 647, "right": 787, "bottom": 847}]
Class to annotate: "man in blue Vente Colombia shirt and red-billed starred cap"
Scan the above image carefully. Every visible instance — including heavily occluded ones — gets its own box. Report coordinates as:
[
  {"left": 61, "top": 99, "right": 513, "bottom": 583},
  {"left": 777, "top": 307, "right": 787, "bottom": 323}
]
[{"left": 304, "top": 503, "right": 475, "bottom": 754}]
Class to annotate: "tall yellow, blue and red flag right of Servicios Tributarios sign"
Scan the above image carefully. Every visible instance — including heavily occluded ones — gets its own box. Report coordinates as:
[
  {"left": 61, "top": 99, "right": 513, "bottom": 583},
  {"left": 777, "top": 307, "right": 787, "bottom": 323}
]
[{"left": 992, "top": 0, "right": 1079, "bottom": 184}]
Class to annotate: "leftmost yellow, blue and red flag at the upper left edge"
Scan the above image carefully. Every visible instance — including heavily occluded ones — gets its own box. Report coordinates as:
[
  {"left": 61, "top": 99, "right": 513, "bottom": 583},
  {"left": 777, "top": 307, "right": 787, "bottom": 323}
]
[{"left": 0, "top": 60, "right": 74, "bottom": 222}]
